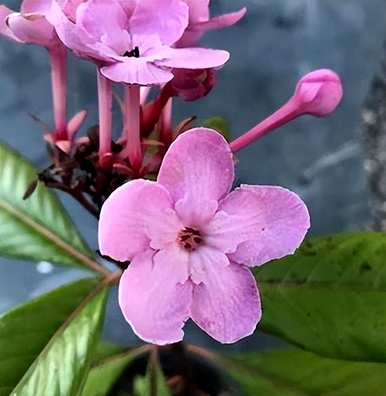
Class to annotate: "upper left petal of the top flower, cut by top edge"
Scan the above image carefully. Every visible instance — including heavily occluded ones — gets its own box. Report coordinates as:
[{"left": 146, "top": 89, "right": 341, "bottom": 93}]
[{"left": 76, "top": 0, "right": 129, "bottom": 39}]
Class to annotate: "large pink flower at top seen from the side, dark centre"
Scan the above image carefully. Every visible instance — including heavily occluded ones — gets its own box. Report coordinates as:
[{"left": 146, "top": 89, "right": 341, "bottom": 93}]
[{"left": 48, "top": 0, "right": 229, "bottom": 85}]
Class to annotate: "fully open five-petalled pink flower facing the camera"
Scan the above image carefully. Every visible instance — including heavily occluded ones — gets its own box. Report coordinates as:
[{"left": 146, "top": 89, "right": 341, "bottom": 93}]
[{"left": 99, "top": 128, "right": 309, "bottom": 344}]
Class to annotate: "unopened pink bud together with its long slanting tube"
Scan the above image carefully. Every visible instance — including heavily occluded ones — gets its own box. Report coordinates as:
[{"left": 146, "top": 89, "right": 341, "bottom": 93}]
[{"left": 230, "top": 69, "right": 343, "bottom": 152}]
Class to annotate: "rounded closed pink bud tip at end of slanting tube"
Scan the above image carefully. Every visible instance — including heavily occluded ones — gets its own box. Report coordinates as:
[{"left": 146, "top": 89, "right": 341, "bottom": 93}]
[{"left": 293, "top": 69, "right": 343, "bottom": 117}]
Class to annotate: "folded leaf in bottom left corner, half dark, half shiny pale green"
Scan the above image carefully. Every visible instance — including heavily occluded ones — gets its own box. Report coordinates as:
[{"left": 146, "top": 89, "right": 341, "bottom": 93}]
[{"left": 0, "top": 279, "right": 106, "bottom": 396}]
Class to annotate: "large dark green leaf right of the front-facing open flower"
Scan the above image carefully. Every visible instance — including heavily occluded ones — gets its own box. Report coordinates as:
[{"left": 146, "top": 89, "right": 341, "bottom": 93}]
[{"left": 254, "top": 232, "right": 386, "bottom": 362}]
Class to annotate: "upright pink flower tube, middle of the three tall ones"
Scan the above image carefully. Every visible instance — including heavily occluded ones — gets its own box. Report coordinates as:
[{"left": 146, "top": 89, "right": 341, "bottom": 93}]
[{"left": 97, "top": 70, "right": 113, "bottom": 161}]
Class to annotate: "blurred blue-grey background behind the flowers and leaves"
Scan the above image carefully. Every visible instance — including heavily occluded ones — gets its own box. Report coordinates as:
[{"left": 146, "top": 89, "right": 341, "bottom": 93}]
[{"left": 0, "top": 0, "right": 386, "bottom": 349}]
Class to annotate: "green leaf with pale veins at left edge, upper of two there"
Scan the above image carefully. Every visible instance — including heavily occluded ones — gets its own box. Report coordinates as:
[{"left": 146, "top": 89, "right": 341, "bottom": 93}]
[{"left": 0, "top": 144, "right": 92, "bottom": 265}]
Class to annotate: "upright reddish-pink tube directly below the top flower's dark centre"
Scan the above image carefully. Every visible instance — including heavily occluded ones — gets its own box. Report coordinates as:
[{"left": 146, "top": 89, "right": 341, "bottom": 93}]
[{"left": 123, "top": 84, "right": 142, "bottom": 171}]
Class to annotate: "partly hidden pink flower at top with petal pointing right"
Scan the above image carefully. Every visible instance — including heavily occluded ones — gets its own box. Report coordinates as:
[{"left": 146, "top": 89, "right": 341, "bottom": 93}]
[{"left": 177, "top": 0, "right": 247, "bottom": 47}]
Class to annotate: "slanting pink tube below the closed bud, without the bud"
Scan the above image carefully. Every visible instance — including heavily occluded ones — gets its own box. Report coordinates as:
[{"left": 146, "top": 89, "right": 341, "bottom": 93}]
[{"left": 230, "top": 98, "right": 301, "bottom": 152}]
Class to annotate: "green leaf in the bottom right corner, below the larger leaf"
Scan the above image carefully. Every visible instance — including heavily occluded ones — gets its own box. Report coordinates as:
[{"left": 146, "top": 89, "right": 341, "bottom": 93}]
[{"left": 225, "top": 349, "right": 386, "bottom": 396}]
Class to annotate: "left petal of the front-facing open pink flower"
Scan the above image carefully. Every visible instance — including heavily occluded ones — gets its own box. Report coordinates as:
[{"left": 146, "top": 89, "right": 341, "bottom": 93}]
[{"left": 99, "top": 180, "right": 181, "bottom": 261}]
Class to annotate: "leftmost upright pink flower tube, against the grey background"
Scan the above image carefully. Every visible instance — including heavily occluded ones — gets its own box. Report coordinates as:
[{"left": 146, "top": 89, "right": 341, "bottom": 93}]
[{"left": 49, "top": 46, "right": 68, "bottom": 140}]
